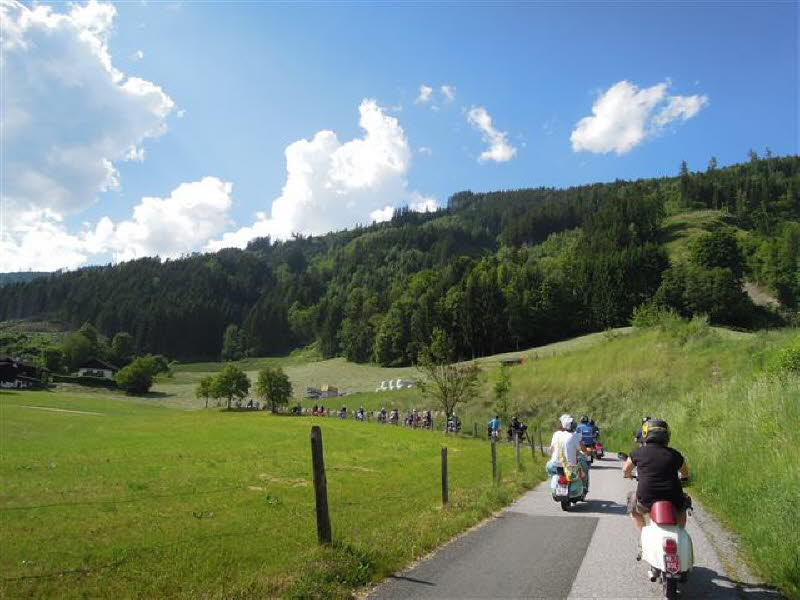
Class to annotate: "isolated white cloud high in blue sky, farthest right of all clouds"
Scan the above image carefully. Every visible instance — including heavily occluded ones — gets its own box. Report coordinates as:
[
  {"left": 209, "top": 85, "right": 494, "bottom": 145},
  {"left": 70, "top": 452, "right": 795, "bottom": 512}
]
[{"left": 570, "top": 81, "right": 708, "bottom": 154}]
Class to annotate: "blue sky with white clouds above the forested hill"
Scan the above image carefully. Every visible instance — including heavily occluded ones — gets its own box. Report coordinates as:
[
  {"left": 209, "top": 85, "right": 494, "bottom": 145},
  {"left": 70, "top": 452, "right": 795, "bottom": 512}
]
[{"left": 2, "top": 0, "right": 798, "bottom": 270}]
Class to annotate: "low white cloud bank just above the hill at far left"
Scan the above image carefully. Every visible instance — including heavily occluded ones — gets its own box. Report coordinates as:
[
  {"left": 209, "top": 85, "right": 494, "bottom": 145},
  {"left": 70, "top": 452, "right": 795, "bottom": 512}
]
[{"left": 0, "top": 177, "right": 233, "bottom": 271}]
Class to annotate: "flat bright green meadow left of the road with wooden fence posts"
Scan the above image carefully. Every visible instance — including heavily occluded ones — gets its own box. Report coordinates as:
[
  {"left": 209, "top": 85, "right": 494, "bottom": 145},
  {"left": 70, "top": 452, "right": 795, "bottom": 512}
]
[{"left": 0, "top": 392, "right": 542, "bottom": 598}]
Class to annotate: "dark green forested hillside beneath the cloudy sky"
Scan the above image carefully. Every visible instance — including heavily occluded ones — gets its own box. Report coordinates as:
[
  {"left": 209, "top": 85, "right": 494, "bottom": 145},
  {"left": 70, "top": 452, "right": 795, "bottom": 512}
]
[{"left": 0, "top": 153, "right": 800, "bottom": 366}]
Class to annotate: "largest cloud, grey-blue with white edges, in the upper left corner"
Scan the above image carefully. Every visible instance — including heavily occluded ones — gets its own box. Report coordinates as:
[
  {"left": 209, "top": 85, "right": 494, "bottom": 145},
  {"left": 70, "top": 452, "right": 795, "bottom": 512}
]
[{"left": 0, "top": 0, "right": 174, "bottom": 216}]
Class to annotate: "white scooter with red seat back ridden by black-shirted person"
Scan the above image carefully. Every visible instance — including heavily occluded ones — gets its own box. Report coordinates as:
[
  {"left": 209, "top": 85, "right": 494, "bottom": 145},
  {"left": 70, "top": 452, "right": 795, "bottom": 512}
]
[{"left": 641, "top": 500, "right": 694, "bottom": 600}]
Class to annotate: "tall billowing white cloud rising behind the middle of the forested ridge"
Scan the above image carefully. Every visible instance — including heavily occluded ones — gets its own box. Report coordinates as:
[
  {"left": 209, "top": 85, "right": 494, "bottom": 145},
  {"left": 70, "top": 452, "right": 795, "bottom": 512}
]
[{"left": 207, "top": 99, "right": 432, "bottom": 250}]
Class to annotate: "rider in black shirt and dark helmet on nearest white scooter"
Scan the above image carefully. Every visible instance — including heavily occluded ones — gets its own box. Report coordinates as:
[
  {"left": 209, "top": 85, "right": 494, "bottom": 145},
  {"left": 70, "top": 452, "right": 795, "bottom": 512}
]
[{"left": 622, "top": 419, "right": 689, "bottom": 533}]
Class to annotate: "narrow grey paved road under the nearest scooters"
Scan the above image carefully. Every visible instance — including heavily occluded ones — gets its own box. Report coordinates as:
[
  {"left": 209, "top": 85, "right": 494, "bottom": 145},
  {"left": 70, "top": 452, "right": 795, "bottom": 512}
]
[{"left": 370, "top": 459, "right": 774, "bottom": 600}]
